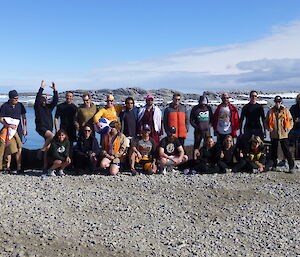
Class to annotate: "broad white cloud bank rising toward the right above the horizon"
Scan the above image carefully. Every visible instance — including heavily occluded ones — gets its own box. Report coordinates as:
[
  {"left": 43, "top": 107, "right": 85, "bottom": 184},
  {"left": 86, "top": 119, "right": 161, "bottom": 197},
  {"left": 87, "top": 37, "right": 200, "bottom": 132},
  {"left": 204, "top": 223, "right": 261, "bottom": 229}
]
[{"left": 0, "top": 21, "right": 300, "bottom": 91}]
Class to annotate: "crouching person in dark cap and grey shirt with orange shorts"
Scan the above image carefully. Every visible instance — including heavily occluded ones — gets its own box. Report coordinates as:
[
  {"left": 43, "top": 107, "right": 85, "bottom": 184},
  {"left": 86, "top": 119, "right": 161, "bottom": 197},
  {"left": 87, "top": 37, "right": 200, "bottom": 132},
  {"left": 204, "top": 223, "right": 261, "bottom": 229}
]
[{"left": 130, "top": 124, "right": 157, "bottom": 176}]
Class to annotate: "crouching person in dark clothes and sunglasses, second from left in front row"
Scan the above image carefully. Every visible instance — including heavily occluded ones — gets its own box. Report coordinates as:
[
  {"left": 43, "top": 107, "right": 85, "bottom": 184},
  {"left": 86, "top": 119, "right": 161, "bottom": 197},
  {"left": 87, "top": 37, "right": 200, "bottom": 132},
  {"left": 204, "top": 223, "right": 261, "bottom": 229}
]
[{"left": 73, "top": 125, "right": 100, "bottom": 173}]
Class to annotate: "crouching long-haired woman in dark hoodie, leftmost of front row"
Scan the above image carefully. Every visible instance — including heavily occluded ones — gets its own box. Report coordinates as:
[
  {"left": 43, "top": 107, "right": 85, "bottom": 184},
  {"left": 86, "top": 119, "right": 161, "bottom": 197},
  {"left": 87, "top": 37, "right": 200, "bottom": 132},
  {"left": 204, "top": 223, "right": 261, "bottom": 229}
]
[{"left": 47, "top": 129, "right": 71, "bottom": 176}]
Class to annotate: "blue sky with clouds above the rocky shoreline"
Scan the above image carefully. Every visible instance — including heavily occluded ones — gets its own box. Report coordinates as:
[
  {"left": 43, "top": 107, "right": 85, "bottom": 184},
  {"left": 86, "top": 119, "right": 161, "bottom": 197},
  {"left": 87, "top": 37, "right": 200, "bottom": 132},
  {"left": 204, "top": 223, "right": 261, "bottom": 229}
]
[{"left": 0, "top": 0, "right": 300, "bottom": 93}]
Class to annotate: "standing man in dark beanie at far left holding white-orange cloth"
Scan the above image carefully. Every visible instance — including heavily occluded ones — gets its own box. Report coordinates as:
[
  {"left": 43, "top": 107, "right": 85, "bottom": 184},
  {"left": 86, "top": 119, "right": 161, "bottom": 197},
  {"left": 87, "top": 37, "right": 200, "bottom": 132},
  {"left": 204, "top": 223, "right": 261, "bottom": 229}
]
[{"left": 0, "top": 90, "right": 27, "bottom": 172}]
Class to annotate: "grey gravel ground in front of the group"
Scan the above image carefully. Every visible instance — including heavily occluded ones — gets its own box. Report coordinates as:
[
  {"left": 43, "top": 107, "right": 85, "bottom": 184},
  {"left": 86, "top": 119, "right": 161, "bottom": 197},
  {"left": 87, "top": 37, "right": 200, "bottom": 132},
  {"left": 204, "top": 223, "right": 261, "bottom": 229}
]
[{"left": 0, "top": 168, "right": 300, "bottom": 256}]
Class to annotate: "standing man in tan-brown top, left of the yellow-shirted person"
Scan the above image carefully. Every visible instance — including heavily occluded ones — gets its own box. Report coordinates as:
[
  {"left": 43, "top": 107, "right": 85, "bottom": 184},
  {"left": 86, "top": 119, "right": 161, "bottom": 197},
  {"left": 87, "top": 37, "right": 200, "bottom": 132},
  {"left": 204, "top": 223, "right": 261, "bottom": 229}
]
[{"left": 75, "top": 94, "right": 97, "bottom": 131}]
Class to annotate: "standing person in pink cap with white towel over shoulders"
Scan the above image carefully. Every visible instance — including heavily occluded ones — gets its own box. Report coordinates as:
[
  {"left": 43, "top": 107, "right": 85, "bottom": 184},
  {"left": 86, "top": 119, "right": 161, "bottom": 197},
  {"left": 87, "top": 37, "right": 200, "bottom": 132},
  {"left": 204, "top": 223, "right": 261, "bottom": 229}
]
[{"left": 138, "top": 95, "right": 163, "bottom": 145}]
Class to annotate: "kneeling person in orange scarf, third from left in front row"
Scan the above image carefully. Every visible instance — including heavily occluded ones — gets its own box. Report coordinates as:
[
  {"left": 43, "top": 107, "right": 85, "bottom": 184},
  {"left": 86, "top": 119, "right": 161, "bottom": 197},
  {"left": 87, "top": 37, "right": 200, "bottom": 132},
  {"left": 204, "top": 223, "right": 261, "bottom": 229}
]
[{"left": 100, "top": 120, "right": 127, "bottom": 176}]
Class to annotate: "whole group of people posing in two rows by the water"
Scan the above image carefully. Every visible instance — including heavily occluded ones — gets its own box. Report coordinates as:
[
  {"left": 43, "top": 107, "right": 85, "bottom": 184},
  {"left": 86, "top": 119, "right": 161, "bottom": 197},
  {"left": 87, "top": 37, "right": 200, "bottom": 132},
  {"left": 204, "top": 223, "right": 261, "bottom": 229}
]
[{"left": 0, "top": 81, "right": 300, "bottom": 176}]
